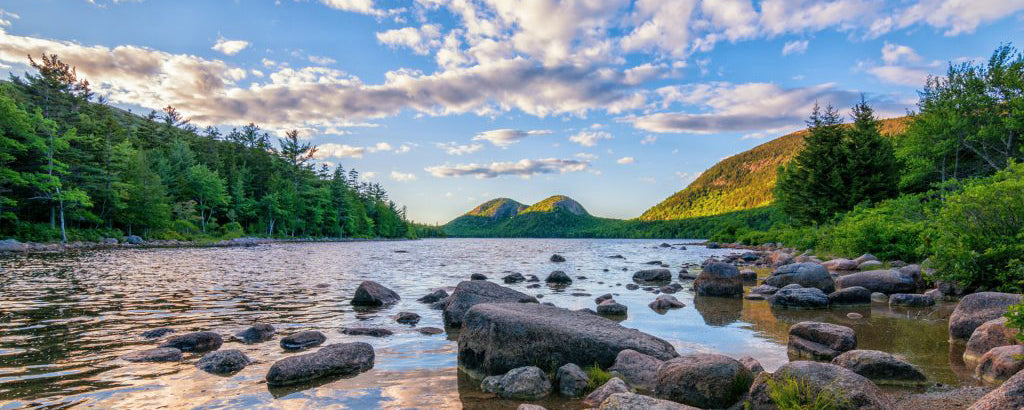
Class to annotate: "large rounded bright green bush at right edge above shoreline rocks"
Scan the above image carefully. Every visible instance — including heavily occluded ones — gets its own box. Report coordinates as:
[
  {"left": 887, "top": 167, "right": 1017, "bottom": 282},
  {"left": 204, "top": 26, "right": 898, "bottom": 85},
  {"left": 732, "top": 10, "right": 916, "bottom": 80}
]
[{"left": 933, "top": 164, "right": 1024, "bottom": 292}]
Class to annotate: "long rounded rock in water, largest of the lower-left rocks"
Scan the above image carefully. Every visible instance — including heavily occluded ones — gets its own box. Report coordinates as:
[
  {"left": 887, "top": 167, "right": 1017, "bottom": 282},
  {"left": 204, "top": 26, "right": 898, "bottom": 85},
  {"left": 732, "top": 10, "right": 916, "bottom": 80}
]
[{"left": 266, "top": 341, "right": 374, "bottom": 386}]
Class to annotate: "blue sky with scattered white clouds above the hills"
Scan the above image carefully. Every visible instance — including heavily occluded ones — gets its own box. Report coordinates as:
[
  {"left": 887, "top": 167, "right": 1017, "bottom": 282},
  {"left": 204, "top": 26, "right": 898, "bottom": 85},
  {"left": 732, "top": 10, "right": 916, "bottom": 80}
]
[{"left": 0, "top": 0, "right": 1024, "bottom": 223}]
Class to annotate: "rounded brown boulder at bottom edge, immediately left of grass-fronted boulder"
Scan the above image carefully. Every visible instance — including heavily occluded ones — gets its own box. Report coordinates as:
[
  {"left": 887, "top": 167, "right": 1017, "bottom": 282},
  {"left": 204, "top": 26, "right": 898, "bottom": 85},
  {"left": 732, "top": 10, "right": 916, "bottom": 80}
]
[{"left": 654, "top": 354, "right": 754, "bottom": 409}]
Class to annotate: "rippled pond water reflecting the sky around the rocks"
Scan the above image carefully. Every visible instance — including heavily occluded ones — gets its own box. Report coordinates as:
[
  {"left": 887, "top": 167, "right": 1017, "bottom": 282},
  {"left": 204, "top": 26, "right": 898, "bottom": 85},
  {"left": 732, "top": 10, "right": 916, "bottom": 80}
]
[{"left": 0, "top": 239, "right": 970, "bottom": 409}]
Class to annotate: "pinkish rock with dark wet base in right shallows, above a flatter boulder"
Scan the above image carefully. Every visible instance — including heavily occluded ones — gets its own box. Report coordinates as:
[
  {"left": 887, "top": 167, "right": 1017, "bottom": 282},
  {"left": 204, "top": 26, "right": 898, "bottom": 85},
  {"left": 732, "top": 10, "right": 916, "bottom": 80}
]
[{"left": 787, "top": 322, "right": 857, "bottom": 361}]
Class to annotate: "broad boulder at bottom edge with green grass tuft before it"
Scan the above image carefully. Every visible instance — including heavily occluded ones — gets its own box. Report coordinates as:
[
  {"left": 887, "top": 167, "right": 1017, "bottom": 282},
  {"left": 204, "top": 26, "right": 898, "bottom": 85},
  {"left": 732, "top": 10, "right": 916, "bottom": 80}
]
[{"left": 750, "top": 361, "right": 895, "bottom": 410}]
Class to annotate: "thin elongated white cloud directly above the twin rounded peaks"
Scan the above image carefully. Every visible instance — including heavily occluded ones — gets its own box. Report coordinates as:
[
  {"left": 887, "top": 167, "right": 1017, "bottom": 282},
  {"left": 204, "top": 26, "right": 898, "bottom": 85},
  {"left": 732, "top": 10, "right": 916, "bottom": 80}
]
[{"left": 425, "top": 158, "right": 590, "bottom": 179}]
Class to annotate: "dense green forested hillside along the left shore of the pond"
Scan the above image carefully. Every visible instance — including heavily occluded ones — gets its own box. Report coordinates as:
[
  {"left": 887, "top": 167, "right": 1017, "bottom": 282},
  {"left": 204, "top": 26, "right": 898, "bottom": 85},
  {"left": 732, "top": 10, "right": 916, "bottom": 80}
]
[{"left": 0, "top": 55, "right": 416, "bottom": 241}]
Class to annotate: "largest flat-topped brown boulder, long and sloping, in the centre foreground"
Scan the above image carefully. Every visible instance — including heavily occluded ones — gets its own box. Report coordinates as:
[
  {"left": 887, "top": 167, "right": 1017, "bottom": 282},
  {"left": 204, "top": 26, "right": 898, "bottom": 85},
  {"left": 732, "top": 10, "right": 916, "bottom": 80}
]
[{"left": 459, "top": 303, "right": 677, "bottom": 374}]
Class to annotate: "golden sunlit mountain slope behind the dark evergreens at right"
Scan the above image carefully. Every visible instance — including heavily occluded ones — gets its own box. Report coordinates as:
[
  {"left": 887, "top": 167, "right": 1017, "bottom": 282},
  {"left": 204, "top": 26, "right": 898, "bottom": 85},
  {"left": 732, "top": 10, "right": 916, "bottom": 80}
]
[{"left": 640, "top": 117, "right": 909, "bottom": 220}]
